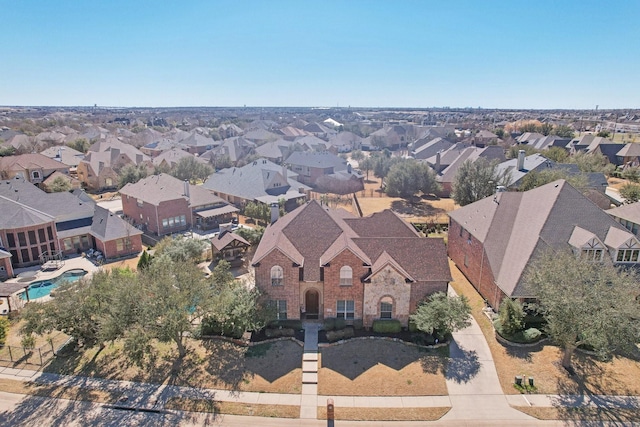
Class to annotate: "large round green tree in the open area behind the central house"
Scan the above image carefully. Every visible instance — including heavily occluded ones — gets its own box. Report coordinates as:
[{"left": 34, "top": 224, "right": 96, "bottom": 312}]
[{"left": 386, "top": 160, "right": 440, "bottom": 199}]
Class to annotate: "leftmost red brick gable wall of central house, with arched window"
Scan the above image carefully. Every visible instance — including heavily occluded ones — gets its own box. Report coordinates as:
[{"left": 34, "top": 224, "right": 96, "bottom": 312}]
[{"left": 255, "top": 250, "right": 300, "bottom": 319}]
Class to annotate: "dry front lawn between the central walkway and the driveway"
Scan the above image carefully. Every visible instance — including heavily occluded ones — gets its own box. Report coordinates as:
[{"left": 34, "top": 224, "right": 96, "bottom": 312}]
[{"left": 318, "top": 340, "right": 448, "bottom": 396}]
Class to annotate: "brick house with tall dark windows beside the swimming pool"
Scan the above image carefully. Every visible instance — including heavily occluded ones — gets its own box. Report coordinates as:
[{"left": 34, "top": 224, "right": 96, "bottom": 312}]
[{"left": 0, "top": 177, "right": 142, "bottom": 267}]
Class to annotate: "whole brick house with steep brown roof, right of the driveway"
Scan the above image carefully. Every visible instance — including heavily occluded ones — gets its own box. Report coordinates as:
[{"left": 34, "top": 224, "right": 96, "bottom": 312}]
[{"left": 448, "top": 180, "right": 640, "bottom": 309}]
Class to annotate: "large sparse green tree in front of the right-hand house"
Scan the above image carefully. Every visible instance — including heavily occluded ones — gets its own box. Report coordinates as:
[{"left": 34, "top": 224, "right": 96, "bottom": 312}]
[{"left": 524, "top": 251, "right": 640, "bottom": 370}]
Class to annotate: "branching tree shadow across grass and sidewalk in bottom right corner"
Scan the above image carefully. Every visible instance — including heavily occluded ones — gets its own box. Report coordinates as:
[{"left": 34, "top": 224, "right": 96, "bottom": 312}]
[{"left": 551, "top": 354, "right": 640, "bottom": 427}]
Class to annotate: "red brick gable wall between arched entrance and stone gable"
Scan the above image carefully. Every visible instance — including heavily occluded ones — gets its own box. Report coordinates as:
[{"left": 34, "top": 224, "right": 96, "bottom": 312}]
[{"left": 323, "top": 250, "right": 369, "bottom": 319}]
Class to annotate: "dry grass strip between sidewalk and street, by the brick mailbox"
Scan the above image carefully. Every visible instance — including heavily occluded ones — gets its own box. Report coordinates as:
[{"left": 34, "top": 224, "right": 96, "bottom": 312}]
[{"left": 318, "top": 406, "right": 451, "bottom": 421}]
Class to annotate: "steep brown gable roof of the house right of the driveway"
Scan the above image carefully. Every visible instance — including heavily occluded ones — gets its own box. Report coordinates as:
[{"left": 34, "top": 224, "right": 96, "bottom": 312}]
[{"left": 449, "top": 180, "right": 629, "bottom": 297}]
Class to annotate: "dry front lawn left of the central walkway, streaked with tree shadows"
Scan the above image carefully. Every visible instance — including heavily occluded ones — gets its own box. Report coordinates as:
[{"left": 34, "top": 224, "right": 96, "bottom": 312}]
[{"left": 44, "top": 340, "right": 302, "bottom": 393}]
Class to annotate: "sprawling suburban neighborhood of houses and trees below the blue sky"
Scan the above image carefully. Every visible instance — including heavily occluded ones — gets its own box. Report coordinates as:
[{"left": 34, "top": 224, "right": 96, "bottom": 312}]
[{"left": 0, "top": 103, "right": 640, "bottom": 425}]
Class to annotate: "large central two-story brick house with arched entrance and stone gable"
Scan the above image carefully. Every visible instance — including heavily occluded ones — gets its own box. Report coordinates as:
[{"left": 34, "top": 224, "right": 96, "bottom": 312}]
[{"left": 252, "top": 201, "right": 451, "bottom": 327}]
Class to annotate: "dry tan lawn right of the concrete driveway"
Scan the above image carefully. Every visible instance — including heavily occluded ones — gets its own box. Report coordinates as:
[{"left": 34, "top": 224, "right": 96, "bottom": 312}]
[{"left": 450, "top": 262, "right": 640, "bottom": 396}]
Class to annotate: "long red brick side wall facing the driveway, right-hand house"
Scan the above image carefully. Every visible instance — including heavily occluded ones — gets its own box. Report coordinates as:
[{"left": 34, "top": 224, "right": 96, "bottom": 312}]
[{"left": 447, "top": 220, "right": 505, "bottom": 309}]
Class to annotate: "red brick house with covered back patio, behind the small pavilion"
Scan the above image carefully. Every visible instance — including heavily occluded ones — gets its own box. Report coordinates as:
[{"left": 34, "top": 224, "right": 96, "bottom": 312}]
[{"left": 120, "top": 173, "right": 238, "bottom": 236}]
